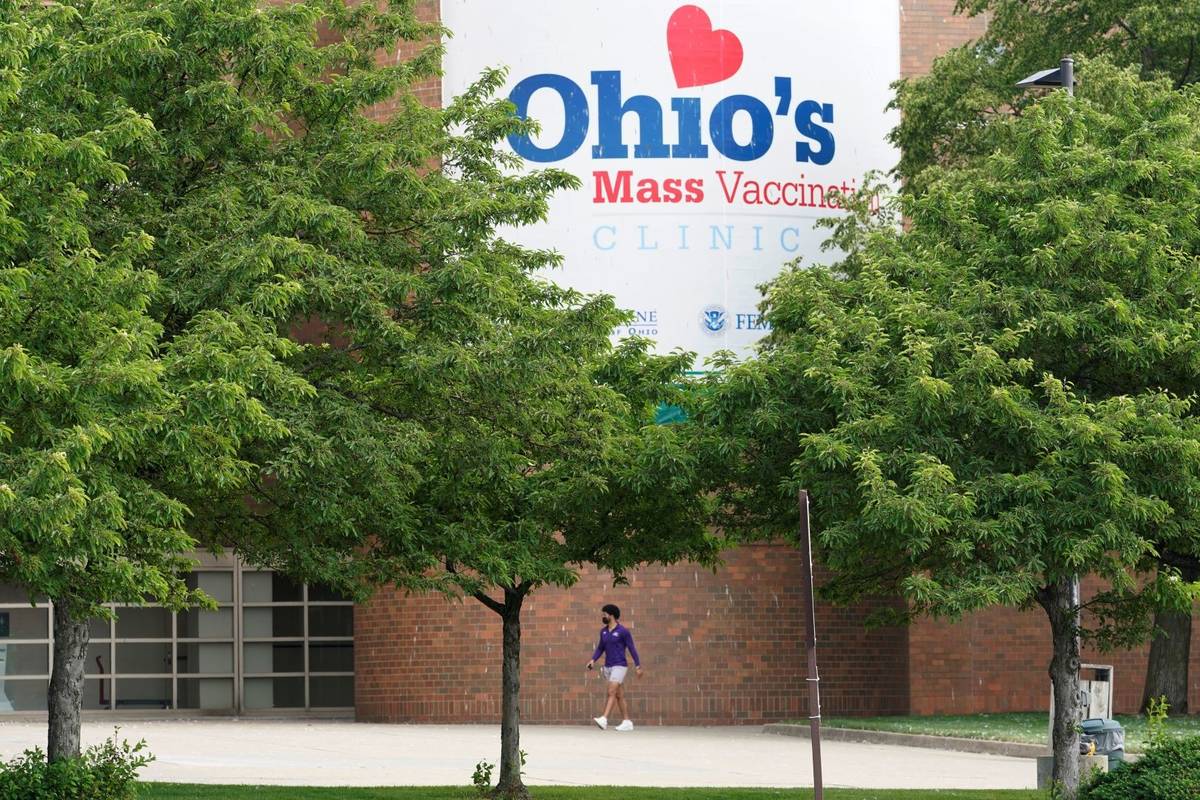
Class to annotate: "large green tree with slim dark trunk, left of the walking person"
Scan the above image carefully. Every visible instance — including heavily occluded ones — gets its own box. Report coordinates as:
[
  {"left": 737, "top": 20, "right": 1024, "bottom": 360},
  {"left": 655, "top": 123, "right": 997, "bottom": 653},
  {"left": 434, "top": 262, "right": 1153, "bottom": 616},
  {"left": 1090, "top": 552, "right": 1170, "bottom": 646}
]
[{"left": 11, "top": 0, "right": 719, "bottom": 796}]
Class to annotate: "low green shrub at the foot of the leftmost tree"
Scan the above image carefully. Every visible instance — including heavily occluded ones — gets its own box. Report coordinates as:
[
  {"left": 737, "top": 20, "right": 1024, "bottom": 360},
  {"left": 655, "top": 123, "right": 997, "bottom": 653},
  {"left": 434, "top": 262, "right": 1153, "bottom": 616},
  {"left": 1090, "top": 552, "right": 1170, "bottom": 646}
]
[{"left": 0, "top": 734, "right": 154, "bottom": 800}]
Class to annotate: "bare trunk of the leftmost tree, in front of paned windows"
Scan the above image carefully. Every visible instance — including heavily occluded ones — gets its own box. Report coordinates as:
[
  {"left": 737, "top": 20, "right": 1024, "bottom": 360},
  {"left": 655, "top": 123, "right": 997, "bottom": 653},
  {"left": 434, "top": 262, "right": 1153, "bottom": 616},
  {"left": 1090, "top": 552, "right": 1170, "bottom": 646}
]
[{"left": 46, "top": 602, "right": 90, "bottom": 762}]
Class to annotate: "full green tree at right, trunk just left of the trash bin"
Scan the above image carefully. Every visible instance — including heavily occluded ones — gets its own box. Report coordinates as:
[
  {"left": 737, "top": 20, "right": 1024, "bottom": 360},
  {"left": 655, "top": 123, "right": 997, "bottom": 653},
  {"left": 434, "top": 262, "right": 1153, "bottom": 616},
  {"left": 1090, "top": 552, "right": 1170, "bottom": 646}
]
[{"left": 695, "top": 62, "right": 1200, "bottom": 796}]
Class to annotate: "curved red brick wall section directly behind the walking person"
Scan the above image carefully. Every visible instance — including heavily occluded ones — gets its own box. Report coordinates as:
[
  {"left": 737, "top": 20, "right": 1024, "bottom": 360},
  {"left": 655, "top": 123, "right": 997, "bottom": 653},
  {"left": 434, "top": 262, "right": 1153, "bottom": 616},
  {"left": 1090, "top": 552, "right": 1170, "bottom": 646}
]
[{"left": 354, "top": 546, "right": 908, "bottom": 724}]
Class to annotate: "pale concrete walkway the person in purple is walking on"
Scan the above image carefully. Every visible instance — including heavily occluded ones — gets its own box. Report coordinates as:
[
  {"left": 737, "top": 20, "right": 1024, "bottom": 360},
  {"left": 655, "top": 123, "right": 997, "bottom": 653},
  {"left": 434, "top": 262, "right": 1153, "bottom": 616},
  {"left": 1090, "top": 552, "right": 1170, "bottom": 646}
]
[{"left": 0, "top": 720, "right": 1036, "bottom": 789}]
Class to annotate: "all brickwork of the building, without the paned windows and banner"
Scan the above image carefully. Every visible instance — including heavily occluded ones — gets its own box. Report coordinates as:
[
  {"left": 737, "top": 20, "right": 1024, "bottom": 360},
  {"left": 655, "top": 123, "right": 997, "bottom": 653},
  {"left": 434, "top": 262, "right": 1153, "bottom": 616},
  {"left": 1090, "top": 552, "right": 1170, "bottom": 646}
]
[{"left": 355, "top": 0, "right": 1200, "bottom": 724}]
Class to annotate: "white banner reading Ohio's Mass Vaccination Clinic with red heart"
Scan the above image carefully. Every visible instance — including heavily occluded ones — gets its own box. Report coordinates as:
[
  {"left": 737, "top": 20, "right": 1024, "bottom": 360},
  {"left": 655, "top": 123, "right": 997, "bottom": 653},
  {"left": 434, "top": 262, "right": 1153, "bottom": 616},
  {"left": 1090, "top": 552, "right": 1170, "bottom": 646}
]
[{"left": 442, "top": 0, "right": 900, "bottom": 359}]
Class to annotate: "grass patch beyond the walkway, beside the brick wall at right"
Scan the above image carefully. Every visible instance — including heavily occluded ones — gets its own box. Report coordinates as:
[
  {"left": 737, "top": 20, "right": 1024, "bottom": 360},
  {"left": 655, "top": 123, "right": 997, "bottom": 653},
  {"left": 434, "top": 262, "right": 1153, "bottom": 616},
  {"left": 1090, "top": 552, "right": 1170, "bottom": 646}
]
[{"left": 797, "top": 712, "right": 1200, "bottom": 752}]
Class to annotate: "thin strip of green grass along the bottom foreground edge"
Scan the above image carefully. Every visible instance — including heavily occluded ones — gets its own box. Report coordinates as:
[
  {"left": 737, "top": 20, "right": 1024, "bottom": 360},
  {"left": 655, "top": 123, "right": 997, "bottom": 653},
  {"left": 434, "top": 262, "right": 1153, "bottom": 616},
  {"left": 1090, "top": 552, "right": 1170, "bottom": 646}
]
[{"left": 139, "top": 783, "right": 1045, "bottom": 800}]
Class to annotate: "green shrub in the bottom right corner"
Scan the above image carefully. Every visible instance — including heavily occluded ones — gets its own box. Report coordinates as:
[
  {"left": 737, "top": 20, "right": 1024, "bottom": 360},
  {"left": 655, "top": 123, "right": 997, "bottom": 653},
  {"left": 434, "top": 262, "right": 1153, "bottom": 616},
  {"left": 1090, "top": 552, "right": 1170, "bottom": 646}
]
[{"left": 1079, "top": 736, "right": 1200, "bottom": 800}]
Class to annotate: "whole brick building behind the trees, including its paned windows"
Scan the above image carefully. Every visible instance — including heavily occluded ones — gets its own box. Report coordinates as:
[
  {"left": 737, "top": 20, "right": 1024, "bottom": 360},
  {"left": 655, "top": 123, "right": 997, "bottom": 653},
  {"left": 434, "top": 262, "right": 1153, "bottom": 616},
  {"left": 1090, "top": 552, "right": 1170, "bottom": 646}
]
[{"left": 0, "top": 0, "right": 1200, "bottom": 724}]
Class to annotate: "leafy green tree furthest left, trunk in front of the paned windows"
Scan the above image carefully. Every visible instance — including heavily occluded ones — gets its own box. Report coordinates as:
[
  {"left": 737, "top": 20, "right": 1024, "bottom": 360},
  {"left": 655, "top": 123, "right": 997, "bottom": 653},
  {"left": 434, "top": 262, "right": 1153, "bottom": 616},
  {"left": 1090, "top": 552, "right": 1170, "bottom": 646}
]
[{"left": 2, "top": 0, "right": 452, "bottom": 758}]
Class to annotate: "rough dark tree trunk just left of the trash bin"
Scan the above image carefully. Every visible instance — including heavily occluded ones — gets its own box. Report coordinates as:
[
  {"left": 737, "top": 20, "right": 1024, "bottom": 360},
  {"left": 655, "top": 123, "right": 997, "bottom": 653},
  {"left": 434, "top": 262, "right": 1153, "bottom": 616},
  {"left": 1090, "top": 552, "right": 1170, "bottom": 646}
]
[{"left": 1038, "top": 579, "right": 1082, "bottom": 800}]
